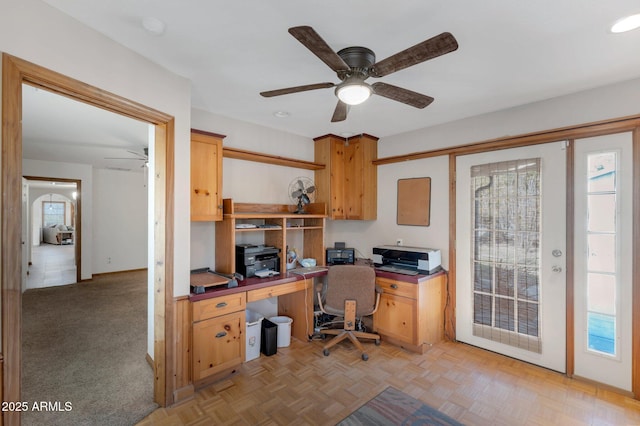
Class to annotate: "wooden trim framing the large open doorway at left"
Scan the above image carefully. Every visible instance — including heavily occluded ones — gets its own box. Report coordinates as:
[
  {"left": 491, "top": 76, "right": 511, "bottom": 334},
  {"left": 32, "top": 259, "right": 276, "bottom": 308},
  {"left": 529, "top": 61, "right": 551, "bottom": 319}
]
[{"left": 0, "top": 53, "right": 175, "bottom": 424}]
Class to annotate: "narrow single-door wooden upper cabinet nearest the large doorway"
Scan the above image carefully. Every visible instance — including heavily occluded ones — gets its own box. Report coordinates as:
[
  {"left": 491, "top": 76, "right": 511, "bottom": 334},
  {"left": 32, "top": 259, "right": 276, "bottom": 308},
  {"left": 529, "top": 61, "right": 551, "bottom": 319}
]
[{"left": 191, "top": 130, "right": 224, "bottom": 222}]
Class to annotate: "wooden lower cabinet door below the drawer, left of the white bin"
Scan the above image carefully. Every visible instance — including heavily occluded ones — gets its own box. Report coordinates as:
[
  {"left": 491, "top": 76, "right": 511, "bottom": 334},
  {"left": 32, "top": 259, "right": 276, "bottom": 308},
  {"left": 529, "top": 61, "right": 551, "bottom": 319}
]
[{"left": 193, "top": 311, "right": 245, "bottom": 380}]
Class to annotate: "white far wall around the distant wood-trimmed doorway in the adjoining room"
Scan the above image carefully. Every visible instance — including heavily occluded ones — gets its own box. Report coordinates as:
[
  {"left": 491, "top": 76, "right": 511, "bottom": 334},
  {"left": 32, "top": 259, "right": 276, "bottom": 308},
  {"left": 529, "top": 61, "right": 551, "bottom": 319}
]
[{"left": 22, "top": 160, "right": 94, "bottom": 280}]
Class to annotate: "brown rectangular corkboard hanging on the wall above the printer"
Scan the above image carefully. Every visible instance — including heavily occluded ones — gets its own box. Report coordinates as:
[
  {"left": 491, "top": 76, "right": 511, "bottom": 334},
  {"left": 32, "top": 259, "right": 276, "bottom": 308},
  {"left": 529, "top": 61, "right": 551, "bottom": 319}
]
[{"left": 396, "top": 177, "right": 431, "bottom": 226}]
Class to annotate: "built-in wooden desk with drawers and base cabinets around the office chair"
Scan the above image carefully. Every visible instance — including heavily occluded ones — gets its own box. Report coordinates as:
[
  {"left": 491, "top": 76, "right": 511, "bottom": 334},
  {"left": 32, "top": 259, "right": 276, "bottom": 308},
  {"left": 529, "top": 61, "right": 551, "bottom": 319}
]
[{"left": 189, "top": 269, "right": 446, "bottom": 386}]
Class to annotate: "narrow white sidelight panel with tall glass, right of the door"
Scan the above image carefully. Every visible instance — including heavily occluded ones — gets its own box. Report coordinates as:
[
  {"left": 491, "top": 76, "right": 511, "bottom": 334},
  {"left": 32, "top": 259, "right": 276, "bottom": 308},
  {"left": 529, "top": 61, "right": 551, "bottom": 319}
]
[{"left": 574, "top": 133, "right": 633, "bottom": 391}]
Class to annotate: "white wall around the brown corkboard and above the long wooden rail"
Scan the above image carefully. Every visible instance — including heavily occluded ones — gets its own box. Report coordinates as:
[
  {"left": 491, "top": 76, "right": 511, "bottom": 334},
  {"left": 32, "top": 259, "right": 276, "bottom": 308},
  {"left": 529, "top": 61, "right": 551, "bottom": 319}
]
[{"left": 326, "top": 75, "right": 640, "bottom": 269}]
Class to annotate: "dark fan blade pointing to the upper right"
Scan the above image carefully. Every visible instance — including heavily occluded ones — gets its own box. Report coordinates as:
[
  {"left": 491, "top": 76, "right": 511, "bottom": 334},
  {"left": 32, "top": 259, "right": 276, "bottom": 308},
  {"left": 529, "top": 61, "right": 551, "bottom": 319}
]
[{"left": 369, "top": 32, "right": 458, "bottom": 77}]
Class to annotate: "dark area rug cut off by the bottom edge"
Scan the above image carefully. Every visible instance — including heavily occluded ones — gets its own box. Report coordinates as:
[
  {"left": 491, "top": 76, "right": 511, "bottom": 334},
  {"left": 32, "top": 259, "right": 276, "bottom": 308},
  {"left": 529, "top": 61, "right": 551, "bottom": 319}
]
[{"left": 338, "top": 387, "right": 462, "bottom": 426}]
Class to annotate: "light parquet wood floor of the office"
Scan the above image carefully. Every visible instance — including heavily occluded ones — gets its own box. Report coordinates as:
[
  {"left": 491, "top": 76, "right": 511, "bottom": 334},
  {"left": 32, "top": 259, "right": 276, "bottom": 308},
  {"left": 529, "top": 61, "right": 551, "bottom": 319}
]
[{"left": 138, "top": 339, "right": 640, "bottom": 426}]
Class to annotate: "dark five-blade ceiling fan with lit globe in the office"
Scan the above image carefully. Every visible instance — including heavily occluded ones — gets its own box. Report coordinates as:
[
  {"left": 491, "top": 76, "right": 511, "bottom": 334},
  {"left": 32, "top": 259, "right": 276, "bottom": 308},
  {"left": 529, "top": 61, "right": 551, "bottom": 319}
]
[{"left": 260, "top": 26, "right": 458, "bottom": 122}]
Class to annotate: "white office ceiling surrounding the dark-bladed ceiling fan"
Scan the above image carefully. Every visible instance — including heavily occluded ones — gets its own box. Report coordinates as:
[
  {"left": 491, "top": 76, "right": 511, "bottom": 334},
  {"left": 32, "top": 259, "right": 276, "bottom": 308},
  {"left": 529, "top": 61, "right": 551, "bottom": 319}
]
[{"left": 25, "top": 0, "right": 640, "bottom": 168}]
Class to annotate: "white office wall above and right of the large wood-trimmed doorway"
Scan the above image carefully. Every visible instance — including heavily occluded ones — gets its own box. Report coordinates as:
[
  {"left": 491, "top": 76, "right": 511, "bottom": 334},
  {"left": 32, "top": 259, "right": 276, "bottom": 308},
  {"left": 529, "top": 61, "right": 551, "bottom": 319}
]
[{"left": 0, "top": 0, "right": 191, "bottom": 296}]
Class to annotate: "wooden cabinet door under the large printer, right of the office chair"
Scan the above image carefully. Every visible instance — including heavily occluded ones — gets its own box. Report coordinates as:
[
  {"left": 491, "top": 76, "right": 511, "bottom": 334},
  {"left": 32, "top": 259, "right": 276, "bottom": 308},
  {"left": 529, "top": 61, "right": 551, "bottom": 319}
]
[{"left": 374, "top": 293, "right": 416, "bottom": 345}]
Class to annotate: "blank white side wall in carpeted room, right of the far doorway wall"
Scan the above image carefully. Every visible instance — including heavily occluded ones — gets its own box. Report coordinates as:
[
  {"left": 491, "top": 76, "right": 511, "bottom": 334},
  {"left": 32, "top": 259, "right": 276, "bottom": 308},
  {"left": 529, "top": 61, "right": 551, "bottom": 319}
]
[{"left": 92, "top": 169, "right": 148, "bottom": 274}]
